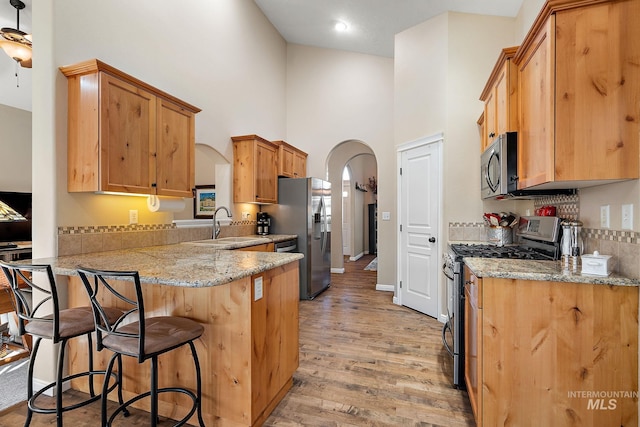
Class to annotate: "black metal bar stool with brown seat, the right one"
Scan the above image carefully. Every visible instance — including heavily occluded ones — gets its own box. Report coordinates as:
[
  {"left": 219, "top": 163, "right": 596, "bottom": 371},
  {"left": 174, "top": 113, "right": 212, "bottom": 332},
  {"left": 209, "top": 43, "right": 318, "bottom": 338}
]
[{"left": 78, "top": 266, "right": 204, "bottom": 427}]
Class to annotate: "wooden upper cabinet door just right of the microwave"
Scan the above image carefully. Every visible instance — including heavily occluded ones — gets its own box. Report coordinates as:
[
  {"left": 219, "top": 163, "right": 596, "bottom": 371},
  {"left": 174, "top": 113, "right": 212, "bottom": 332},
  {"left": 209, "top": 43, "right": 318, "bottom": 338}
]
[{"left": 518, "top": 15, "right": 555, "bottom": 188}]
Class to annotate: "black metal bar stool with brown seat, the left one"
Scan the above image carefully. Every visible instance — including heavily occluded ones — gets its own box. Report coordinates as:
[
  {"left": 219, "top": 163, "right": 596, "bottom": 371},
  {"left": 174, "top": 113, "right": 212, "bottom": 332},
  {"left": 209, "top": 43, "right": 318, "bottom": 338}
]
[{"left": 0, "top": 261, "right": 122, "bottom": 427}]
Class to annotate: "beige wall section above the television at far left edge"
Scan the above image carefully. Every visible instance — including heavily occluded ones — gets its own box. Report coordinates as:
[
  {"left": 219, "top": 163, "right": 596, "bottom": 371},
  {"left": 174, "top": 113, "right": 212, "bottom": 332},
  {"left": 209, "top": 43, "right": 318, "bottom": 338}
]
[{"left": 0, "top": 105, "right": 31, "bottom": 193}]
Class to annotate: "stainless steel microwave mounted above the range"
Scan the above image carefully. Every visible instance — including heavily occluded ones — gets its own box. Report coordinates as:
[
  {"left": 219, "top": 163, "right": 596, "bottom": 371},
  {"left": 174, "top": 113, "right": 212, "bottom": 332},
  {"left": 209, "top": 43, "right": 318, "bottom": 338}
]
[{"left": 480, "top": 132, "right": 518, "bottom": 199}]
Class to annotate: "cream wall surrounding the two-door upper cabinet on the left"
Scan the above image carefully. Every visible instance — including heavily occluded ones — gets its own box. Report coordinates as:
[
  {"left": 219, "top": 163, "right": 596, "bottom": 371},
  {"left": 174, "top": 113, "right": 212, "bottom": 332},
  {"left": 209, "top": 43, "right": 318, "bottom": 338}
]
[{"left": 43, "top": 0, "right": 286, "bottom": 225}]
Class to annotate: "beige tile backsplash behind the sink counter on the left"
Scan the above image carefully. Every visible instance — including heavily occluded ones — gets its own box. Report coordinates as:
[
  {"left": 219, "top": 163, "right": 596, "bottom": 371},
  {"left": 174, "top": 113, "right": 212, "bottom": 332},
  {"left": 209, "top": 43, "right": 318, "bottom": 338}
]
[{"left": 58, "top": 221, "right": 257, "bottom": 256}]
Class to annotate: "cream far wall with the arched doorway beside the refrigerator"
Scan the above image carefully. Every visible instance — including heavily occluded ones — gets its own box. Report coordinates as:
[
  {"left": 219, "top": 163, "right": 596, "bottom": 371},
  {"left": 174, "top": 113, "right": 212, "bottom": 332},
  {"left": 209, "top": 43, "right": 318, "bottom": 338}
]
[{"left": 286, "top": 45, "right": 396, "bottom": 284}]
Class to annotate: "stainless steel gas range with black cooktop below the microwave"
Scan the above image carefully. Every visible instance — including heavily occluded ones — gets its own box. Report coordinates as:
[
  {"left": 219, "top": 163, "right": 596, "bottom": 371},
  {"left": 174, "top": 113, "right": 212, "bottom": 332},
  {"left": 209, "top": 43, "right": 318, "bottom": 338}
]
[{"left": 442, "top": 216, "right": 561, "bottom": 388}]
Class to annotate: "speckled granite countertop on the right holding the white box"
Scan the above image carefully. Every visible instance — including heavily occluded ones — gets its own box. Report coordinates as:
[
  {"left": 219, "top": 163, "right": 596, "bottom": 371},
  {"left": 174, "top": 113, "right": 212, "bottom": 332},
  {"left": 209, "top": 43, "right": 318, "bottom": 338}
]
[{"left": 463, "top": 257, "right": 640, "bottom": 286}]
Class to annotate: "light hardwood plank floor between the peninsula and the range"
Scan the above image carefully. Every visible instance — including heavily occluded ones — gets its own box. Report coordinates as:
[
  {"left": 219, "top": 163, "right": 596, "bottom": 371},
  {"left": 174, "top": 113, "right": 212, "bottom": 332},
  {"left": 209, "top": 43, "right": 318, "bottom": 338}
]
[{"left": 0, "top": 256, "right": 474, "bottom": 427}]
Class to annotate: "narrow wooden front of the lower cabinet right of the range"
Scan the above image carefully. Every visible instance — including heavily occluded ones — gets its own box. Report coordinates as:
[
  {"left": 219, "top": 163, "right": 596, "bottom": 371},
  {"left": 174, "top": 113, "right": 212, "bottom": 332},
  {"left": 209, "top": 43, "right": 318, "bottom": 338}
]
[{"left": 464, "top": 266, "right": 482, "bottom": 427}]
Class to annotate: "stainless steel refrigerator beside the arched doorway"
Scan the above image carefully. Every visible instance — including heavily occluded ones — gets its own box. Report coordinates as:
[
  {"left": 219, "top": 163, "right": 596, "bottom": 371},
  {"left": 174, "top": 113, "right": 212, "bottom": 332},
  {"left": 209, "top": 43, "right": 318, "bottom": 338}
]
[{"left": 262, "top": 178, "right": 331, "bottom": 299}]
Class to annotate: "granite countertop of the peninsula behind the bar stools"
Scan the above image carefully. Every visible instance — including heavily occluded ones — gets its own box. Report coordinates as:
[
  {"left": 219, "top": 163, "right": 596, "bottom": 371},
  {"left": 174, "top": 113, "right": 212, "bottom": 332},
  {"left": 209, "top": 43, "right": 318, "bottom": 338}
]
[{"left": 28, "top": 242, "right": 303, "bottom": 288}]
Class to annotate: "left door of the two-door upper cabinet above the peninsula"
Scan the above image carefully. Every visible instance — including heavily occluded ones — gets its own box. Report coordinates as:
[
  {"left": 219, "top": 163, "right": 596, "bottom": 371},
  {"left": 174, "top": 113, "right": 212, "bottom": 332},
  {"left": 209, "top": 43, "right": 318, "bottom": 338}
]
[{"left": 100, "top": 73, "right": 156, "bottom": 194}]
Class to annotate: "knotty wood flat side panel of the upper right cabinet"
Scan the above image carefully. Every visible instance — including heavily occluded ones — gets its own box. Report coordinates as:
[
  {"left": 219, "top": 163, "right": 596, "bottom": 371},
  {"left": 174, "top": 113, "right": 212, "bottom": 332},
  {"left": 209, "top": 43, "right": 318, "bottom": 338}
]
[{"left": 555, "top": 1, "right": 640, "bottom": 181}]
